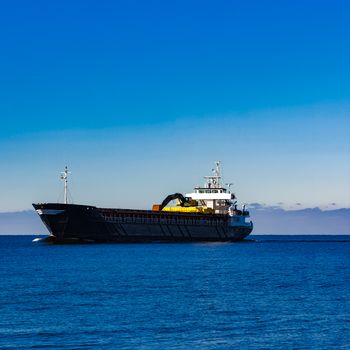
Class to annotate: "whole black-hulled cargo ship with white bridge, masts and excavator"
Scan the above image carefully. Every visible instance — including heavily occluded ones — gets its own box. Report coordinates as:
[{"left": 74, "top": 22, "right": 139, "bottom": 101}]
[{"left": 33, "top": 162, "right": 253, "bottom": 243}]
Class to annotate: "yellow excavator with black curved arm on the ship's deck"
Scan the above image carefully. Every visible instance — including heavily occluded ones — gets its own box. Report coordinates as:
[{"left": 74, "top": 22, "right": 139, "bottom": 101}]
[{"left": 152, "top": 193, "right": 214, "bottom": 214}]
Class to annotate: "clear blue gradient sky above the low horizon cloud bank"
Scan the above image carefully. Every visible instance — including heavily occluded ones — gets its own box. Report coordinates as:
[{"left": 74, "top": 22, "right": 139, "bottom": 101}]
[{"left": 0, "top": 0, "right": 350, "bottom": 212}]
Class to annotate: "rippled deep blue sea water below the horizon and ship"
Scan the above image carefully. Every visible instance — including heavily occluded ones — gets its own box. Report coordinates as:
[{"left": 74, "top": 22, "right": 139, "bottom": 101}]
[{"left": 0, "top": 236, "right": 350, "bottom": 350}]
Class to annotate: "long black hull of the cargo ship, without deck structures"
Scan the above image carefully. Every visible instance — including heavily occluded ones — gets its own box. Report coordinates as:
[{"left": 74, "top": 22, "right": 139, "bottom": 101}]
[{"left": 33, "top": 203, "right": 253, "bottom": 243}]
